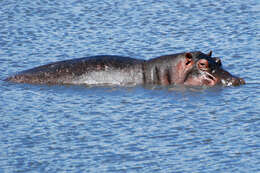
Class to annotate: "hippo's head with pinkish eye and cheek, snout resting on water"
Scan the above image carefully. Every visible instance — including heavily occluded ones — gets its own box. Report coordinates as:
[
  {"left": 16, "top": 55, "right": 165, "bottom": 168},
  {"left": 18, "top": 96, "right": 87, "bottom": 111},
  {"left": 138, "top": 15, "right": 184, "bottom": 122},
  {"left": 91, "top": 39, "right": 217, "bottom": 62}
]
[{"left": 184, "top": 52, "right": 245, "bottom": 86}]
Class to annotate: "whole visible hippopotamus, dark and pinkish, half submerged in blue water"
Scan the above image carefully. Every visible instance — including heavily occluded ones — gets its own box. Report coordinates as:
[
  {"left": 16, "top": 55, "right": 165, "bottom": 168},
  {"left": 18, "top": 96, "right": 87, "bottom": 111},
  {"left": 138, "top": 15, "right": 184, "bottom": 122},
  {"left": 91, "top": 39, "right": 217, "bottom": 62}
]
[{"left": 5, "top": 51, "right": 245, "bottom": 87}]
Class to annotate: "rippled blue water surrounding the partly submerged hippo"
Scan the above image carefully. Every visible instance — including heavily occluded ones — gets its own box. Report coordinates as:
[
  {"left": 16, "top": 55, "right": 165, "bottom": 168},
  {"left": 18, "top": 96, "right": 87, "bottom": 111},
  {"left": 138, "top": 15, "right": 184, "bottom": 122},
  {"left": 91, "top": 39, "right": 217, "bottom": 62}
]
[{"left": 0, "top": 0, "right": 260, "bottom": 173}]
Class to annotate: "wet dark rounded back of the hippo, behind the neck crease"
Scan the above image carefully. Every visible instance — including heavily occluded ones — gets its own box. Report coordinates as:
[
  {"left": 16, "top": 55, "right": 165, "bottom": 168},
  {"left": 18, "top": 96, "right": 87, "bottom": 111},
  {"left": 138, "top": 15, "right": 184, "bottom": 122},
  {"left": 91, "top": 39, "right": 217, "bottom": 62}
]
[{"left": 6, "top": 55, "right": 144, "bottom": 85}]
